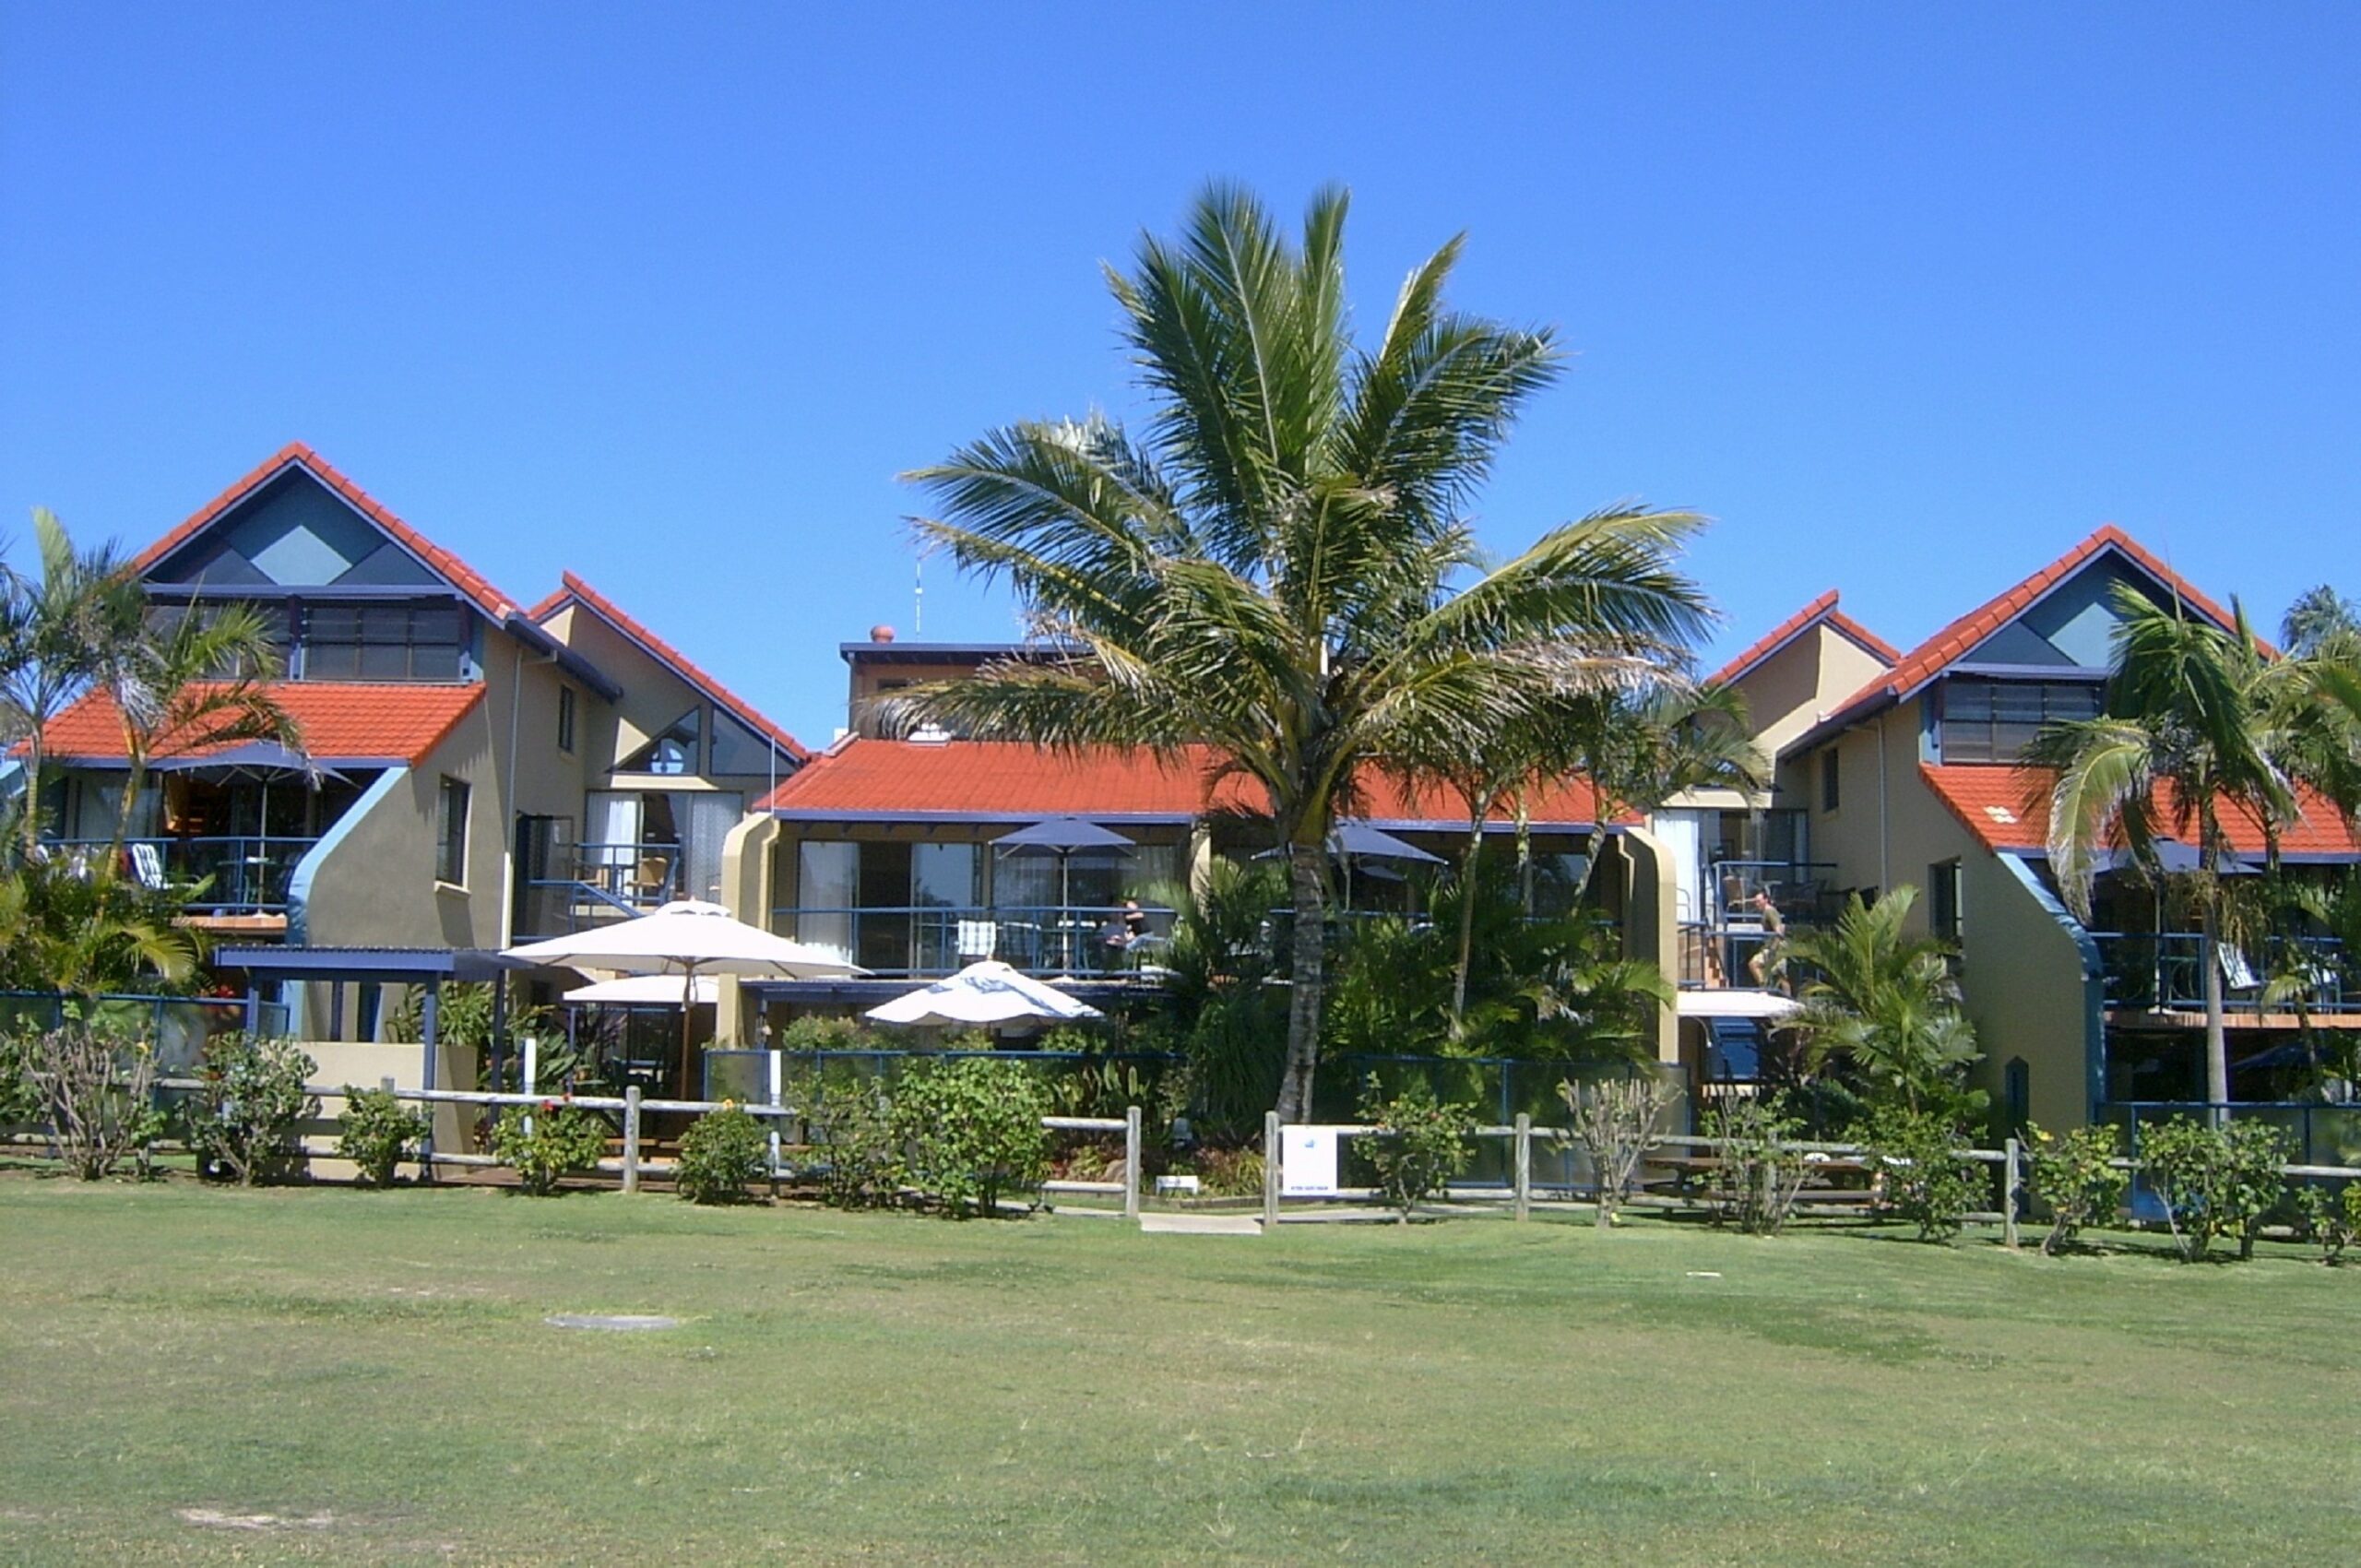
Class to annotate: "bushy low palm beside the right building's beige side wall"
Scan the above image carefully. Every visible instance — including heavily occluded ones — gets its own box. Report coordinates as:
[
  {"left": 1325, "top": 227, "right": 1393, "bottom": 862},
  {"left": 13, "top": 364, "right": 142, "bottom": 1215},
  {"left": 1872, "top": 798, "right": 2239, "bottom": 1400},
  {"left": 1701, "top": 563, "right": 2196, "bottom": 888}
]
[{"left": 1787, "top": 885, "right": 1983, "bottom": 1126}]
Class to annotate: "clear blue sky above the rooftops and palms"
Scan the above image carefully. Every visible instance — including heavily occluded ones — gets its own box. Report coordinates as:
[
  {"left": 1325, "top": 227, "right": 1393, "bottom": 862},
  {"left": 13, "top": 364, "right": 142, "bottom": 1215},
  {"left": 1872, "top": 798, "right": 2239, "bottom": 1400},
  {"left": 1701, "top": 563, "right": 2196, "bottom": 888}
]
[{"left": 0, "top": 0, "right": 2361, "bottom": 742}]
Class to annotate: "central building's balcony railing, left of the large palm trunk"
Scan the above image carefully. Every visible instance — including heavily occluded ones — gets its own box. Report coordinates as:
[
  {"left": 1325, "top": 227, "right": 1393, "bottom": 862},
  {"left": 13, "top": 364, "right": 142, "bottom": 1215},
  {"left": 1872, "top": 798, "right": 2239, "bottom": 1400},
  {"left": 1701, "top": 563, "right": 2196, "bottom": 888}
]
[{"left": 770, "top": 905, "right": 1173, "bottom": 980}]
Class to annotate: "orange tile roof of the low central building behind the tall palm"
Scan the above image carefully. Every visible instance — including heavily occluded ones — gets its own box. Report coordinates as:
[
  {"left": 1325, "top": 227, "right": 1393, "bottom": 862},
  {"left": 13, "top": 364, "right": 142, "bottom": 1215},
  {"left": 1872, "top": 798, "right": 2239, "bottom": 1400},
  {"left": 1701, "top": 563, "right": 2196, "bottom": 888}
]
[{"left": 758, "top": 739, "right": 1636, "bottom": 826}]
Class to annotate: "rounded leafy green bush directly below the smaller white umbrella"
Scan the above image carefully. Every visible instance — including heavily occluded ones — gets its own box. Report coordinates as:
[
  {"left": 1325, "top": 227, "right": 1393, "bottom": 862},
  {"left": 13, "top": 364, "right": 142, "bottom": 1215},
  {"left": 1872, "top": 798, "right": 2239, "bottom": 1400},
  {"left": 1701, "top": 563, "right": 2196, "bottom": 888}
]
[{"left": 890, "top": 1058, "right": 1049, "bottom": 1218}]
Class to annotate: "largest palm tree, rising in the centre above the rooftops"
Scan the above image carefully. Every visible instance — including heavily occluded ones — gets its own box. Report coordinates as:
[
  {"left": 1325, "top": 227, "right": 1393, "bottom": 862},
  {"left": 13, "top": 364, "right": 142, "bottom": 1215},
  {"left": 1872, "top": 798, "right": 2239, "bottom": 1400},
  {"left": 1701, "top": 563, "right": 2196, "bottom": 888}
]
[{"left": 883, "top": 186, "right": 1709, "bottom": 1120}]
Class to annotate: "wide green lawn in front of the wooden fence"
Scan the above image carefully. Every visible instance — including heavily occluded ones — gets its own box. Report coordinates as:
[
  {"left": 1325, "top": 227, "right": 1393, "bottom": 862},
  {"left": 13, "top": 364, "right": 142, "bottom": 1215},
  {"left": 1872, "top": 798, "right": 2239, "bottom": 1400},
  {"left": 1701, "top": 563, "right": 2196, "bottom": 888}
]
[{"left": 0, "top": 1173, "right": 2361, "bottom": 1568}]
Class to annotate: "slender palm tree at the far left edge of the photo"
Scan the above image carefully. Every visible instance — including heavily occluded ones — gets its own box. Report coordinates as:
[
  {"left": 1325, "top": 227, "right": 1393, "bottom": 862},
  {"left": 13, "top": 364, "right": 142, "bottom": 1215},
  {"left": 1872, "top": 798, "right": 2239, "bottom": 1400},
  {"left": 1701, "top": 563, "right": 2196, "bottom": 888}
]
[{"left": 0, "top": 507, "right": 147, "bottom": 850}]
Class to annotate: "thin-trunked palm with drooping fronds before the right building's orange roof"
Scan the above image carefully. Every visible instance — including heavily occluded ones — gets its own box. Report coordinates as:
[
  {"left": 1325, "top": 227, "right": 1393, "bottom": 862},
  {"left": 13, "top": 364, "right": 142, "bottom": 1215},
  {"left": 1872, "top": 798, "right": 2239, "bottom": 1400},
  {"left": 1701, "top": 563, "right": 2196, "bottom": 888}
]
[{"left": 2025, "top": 583, "right": 2295, "bottom": 1105}]
